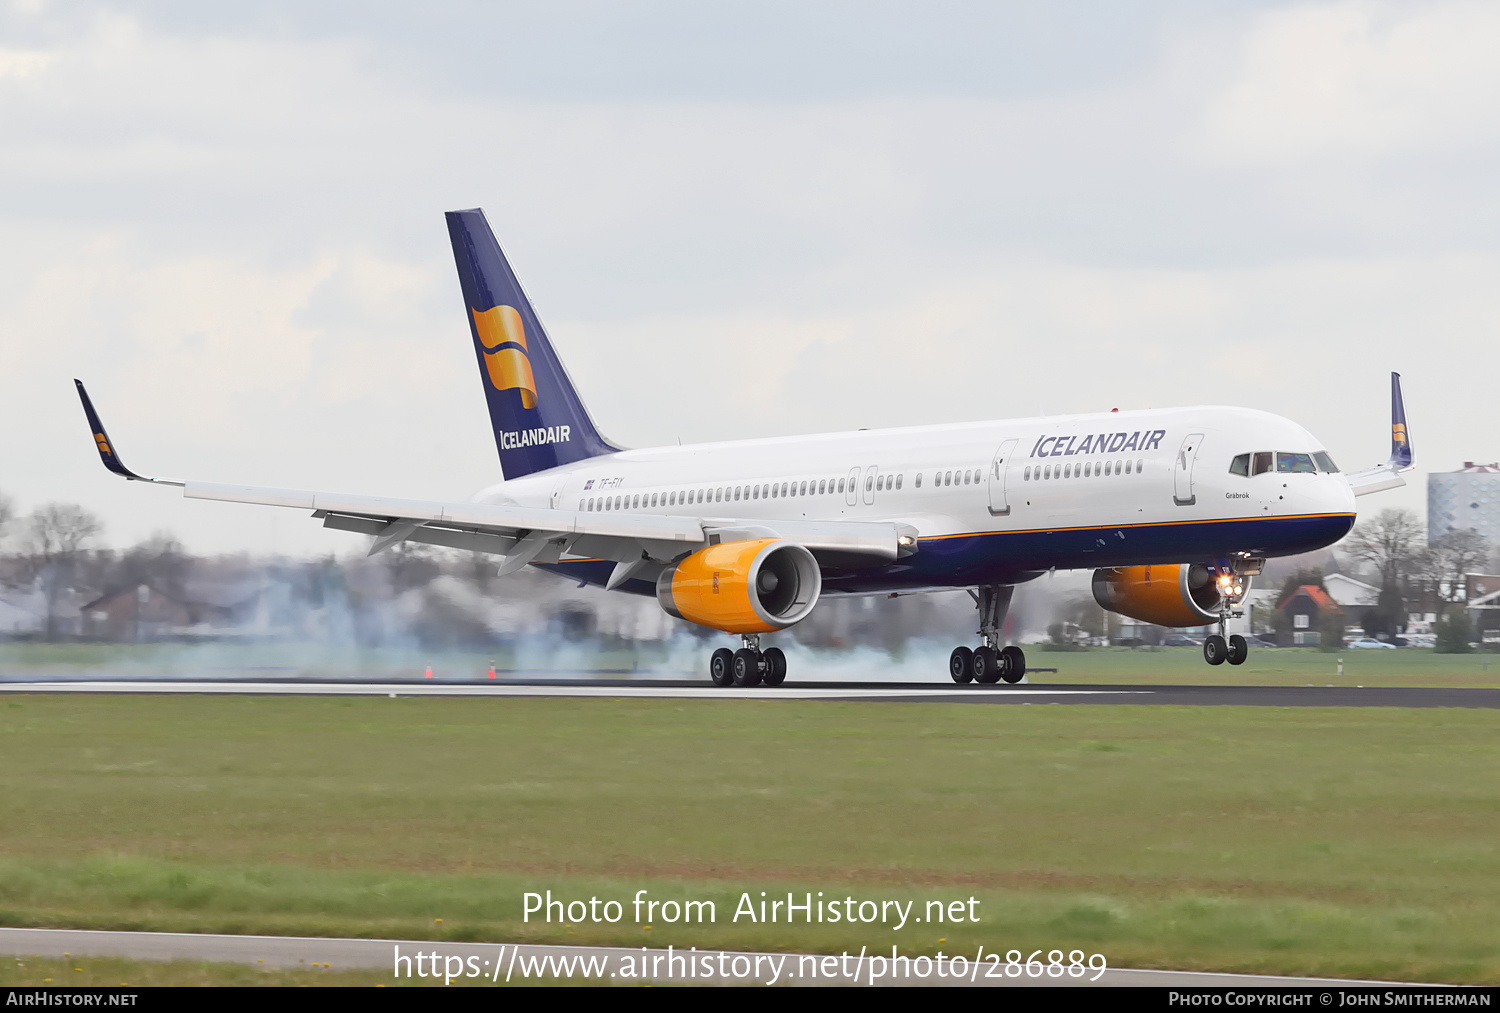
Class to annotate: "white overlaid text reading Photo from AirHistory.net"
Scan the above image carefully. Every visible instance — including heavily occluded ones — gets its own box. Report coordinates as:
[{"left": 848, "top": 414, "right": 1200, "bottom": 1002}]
[{"left": 521, "top": 890, "right": 980, "bottom": 932}]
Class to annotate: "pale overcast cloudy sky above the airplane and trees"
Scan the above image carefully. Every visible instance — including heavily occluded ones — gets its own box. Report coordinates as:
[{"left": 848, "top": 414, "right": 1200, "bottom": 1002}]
[{"left": 0, "top": 0, "right": 1500, "bottom": 554}]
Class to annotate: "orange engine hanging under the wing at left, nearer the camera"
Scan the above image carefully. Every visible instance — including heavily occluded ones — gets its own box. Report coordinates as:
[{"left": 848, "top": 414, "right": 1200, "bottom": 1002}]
[{"left": 657, "top": 539, "right": 824, "bottom": 633}]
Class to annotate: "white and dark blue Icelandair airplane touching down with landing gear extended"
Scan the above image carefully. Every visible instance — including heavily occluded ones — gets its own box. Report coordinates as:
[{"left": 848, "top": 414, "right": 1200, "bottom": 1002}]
[{"left": 74, "top": 209, "right": 1413, "bottom": 686}]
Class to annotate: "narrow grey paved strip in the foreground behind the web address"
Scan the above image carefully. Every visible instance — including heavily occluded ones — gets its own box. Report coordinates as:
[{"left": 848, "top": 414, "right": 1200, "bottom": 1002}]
[{"left": 0, "top": 929, "right": 1446, "bottom": 990}]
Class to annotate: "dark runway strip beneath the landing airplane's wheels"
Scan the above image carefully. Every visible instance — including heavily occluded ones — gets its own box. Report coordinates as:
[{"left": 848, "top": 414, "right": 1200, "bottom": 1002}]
[{"left": 0, "top": 678, "right": 1500, "bottom": 708}]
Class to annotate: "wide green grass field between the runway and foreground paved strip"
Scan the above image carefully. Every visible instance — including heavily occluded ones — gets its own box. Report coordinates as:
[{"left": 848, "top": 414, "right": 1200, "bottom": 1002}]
[{"left": 0, "top": 695, "right": 1500, "bottom": 983}]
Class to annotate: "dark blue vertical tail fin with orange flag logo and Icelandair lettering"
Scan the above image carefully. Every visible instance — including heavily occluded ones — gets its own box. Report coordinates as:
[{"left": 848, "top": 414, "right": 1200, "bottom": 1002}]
[{"left": 447, "top": 209, "right": 620, "bottom": 479}]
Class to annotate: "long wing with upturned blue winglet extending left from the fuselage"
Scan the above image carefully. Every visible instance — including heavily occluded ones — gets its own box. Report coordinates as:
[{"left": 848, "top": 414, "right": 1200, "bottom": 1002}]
[{"left": 74, "top": 380, "right": 917, "bottom": 587}]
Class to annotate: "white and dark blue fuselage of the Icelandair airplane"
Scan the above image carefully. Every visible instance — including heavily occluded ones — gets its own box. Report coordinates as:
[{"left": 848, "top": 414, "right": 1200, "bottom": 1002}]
[{"left": 474, "top": 407, "right": 1355, "bottom": 590}]
